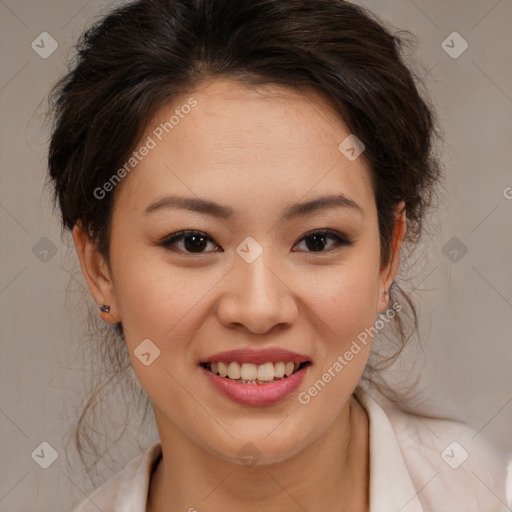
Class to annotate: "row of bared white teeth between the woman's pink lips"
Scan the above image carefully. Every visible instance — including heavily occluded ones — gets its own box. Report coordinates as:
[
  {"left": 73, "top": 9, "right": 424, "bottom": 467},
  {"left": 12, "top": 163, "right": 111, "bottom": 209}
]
[{"left": 201, "top": 361, "right": 311, "bottom": 384}]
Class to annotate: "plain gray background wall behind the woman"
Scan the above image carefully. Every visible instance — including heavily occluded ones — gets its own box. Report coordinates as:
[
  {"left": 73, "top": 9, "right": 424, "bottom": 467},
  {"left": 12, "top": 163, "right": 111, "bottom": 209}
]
[{"left": 0, "top": 0, "right": 512, "bottom": 512}]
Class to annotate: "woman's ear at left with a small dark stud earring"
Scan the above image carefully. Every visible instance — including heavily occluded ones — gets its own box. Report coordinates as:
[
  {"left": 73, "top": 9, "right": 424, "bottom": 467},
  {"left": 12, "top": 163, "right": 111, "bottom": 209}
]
[{"left": 73, "top": 222, "right": 121, "bottom": 323}]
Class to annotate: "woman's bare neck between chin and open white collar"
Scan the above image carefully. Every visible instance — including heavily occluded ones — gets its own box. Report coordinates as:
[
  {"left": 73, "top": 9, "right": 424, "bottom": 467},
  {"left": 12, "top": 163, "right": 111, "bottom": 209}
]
[{"left": 147, "top": 397, "right": 369, "bottom": 512}]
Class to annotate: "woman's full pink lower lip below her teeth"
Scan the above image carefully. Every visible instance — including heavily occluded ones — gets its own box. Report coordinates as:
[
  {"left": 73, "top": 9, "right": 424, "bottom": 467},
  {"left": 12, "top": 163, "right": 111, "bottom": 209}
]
[{"left": 200, "top": 365, "right": 310, "bottom": 405}]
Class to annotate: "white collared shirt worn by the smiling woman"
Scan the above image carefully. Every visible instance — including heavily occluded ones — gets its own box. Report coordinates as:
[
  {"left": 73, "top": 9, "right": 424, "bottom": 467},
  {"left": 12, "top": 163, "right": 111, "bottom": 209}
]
[{"left": 74, "top": 388, "right": 512, "bottom": 512}]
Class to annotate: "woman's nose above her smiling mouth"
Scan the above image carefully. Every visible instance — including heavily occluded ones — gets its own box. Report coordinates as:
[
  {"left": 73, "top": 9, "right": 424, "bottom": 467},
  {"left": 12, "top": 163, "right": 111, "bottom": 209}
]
[{"left": 216, "top": 253, "right": 298, "bottom": 334}]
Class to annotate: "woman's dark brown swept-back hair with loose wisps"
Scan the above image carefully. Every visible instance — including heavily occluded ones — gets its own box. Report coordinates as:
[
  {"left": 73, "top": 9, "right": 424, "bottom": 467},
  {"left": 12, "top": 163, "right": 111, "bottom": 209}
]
[{"left": 48, "top": 0, "right": 440, "bottom": 480}]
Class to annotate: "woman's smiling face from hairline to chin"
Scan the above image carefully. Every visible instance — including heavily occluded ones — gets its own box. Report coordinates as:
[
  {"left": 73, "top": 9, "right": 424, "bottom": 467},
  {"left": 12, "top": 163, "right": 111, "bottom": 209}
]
[{"left": 75, "top": 80, "right": 404, "bottom": 462}]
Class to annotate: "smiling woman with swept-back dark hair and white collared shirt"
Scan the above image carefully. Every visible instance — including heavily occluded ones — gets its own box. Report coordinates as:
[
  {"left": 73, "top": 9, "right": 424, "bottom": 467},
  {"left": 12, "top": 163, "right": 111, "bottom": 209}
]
[{"left": 49, "top": 0, "right": 507, "bottom": 512}]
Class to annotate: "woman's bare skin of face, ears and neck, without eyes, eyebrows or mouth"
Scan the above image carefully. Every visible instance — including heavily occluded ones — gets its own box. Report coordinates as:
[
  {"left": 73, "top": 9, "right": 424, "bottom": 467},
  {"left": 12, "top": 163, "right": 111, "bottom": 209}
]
[{"left": 73, "top": 79, "right": 405, "bottom": 512}]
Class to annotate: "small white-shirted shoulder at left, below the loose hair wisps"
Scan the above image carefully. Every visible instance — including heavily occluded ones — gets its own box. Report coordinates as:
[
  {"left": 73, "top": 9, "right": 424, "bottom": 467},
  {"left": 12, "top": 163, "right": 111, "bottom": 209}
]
[{"left": 73, "top": 441, "right": 161, "bottom": 512}]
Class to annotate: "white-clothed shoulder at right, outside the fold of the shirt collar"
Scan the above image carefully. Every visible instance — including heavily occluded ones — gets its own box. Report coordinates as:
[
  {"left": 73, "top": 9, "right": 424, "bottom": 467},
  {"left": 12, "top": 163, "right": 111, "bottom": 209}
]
[{"left": 358, "top": 388, "right": 511, "bottom": 512}]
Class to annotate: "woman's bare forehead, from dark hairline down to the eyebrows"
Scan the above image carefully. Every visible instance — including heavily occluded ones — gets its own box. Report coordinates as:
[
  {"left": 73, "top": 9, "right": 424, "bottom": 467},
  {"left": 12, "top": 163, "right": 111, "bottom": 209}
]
[{"left": 114, "top": 79, "right": 371, "bottom": 216}]
